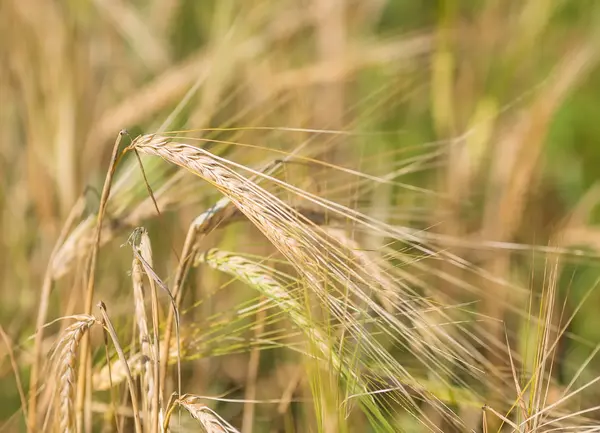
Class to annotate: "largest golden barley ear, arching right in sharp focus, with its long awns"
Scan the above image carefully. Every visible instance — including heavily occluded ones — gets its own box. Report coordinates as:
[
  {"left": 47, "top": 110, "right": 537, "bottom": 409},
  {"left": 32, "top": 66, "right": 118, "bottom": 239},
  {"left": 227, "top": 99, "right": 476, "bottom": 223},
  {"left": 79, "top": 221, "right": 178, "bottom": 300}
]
[{"left": 132, "top": 135, "right": 479, "bottom": 431}]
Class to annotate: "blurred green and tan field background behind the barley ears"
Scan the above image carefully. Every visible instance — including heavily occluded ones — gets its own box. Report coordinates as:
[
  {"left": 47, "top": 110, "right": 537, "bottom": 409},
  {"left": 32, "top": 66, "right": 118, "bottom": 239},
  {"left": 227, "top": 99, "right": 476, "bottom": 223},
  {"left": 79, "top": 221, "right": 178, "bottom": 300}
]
[{"left": 0, "top": 0, "right": 600, "bottom": 431}]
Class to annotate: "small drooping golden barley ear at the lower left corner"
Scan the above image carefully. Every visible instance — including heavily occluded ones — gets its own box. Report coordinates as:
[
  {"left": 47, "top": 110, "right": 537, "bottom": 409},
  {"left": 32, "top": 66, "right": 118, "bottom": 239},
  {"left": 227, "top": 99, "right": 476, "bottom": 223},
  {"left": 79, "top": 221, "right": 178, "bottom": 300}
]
[{"left": 55, "top": 315, "right": 96, "bottom": 432}]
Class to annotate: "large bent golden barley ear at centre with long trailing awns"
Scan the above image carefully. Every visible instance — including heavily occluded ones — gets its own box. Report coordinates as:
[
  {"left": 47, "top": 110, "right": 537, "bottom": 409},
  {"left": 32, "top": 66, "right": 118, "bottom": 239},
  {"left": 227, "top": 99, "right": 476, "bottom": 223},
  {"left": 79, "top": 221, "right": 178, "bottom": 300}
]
[{"left": 131, "top": 135, "right": 468, "bottom": 431}]
